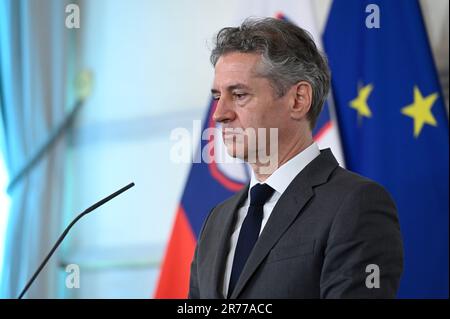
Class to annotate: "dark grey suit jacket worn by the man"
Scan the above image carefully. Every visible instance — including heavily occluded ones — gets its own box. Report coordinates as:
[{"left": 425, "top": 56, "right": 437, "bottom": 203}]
[{"left": 189, "top": 149, "right": 403, "bottom": 298}]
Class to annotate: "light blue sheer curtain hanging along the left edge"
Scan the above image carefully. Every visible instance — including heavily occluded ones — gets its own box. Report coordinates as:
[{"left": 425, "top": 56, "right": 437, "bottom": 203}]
[{"left": 0, "top": 0, "right": 75, "bottom": 298}]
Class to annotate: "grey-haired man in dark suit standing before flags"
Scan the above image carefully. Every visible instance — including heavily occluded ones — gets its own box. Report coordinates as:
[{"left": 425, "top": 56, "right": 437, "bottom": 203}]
[{"left": 189, "top": 18, "right": 403, "bottom": 298}]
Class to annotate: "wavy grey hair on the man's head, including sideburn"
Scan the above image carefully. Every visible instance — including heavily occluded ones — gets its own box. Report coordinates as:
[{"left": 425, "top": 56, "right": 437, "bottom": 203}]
[{"left": 210, "top": 18, "right": 330, "bottom": 129}]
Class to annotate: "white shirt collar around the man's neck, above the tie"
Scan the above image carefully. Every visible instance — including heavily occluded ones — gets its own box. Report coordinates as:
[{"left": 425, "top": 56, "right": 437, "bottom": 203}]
[{"left": 249, "top": 142, "right": 320, "bottom": 198}]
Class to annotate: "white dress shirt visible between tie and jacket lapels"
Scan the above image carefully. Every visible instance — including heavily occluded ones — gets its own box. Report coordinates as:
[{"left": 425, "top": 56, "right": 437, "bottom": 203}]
[{"left": 222, "top": 143, "right": 320, "bottom": 297}]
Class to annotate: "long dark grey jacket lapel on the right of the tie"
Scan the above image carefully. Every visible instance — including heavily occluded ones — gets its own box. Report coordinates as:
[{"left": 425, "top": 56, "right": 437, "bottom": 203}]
[{"left": 232, "top": 149, "right": 338, "bottom": 299}]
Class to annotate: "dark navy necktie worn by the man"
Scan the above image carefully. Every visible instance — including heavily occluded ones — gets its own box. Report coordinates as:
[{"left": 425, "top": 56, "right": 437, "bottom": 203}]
[{"left": 228, "top": 184, "right": 274, "bottom": 297}]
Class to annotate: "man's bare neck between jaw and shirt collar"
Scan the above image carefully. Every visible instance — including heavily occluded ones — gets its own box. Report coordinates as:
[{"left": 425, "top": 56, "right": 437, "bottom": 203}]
[{"left": 250, "top": 134, "right": 314, "bottom": 182}]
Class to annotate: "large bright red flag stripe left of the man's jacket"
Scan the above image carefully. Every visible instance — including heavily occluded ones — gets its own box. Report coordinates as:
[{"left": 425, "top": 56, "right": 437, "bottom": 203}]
[{"left": 155, "top": 205, "right": 196, "bottom": 299}]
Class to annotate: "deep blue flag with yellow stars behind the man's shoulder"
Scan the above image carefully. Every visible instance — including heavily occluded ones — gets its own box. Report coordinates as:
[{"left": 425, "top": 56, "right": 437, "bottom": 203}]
[{"left": 324, "top": 0, "right": 449, "bottom": 298}]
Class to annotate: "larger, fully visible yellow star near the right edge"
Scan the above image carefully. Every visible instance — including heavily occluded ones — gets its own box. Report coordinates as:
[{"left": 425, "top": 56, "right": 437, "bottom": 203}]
[{"left": 402, "top": 86, "right": 438, "bottom": 137}]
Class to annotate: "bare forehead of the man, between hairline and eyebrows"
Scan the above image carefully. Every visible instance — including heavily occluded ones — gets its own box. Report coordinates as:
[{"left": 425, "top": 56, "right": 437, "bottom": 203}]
[{"left": 214, "top": 52, "right": 261, "bottom": 86}]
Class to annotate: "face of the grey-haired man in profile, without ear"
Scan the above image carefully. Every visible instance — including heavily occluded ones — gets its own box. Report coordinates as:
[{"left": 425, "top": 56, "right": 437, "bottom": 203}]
[{"left": 211, "top": 52, "right": 289, "bottom": 161}]
